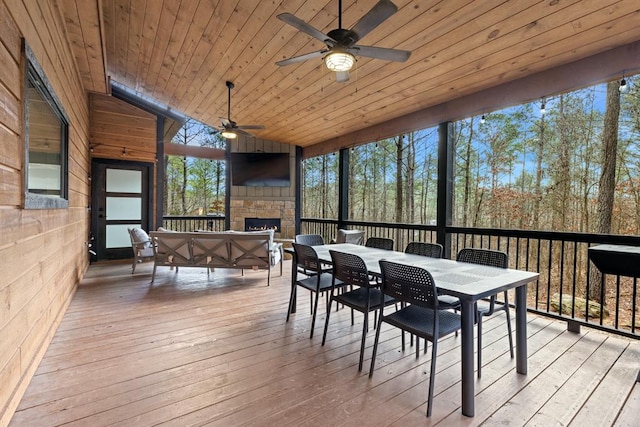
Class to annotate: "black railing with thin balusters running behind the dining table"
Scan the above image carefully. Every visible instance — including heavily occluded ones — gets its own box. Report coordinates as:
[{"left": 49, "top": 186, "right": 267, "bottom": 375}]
[{"left": 298, "top": 218, "right": 640, "bottom": 338}]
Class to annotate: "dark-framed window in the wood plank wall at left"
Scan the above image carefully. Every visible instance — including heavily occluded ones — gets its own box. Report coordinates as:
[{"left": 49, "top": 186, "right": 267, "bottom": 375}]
[{"left": 24, "top": 43, "right": 69, "bottom": 209}]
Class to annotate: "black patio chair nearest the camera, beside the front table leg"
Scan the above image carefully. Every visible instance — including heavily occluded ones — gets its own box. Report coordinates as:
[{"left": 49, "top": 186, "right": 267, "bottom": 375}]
[{"left": 369, "top": 260, "right": 461, "bottom": 417}]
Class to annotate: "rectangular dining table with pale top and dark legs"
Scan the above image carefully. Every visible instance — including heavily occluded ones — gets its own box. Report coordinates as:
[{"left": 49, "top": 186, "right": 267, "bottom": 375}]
[{"left": 294, "top": 243, "right": 539, "bottom": 417}]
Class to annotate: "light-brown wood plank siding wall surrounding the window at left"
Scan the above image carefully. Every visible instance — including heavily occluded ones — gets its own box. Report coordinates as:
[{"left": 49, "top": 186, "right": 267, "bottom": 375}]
[{"left": 0, "top": 0, "right": 90, "bottom": 425}]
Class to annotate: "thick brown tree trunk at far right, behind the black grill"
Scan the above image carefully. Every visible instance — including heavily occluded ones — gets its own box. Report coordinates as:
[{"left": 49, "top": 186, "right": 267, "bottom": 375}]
[{"left": 589, "top": 81, "right": 620, "bottom": 305}]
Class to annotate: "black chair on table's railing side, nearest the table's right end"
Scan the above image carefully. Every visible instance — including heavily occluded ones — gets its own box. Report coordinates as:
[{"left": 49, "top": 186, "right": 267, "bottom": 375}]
[{"left": 456, "top": 248, "right": 513, "bottom": 378}]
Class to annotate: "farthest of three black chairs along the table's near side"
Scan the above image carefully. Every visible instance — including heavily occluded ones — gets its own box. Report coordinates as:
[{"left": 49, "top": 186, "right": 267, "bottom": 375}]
[{"left": 287, "top": 243, "right": 340, "bottom": 338}]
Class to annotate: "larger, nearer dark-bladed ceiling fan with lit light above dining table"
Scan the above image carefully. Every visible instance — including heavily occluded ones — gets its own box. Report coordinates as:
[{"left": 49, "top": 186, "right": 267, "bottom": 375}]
[{"left": 276, "top": 0, "right": 411, "bottom": 82}]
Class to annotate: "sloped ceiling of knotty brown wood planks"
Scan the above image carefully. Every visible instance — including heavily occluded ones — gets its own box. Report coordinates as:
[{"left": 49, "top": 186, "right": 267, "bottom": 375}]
[{"left": 59, "top": 0, "right": 640, "bottom": 147}]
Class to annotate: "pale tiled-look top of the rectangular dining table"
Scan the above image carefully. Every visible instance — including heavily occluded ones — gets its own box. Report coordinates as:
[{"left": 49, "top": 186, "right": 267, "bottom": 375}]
[{"left": 313, "top": 243, "right": 539, "bottom": 301}]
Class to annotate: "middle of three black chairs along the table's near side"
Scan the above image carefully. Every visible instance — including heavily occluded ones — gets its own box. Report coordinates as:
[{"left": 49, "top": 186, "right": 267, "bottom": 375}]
[{"left": 322, "top": 251, "right": 395, "bottom": 371}]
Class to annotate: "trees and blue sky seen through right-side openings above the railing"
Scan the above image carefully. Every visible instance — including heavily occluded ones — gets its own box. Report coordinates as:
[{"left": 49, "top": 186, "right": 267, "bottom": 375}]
[{"left": 302, "top": 76, "right": 640, "bottom": 234}]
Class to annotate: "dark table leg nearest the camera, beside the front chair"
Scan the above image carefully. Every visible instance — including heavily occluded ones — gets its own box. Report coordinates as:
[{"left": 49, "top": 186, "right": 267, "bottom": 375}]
[{"left": 460, "top": 299, "right": 475, "bottom": 417}]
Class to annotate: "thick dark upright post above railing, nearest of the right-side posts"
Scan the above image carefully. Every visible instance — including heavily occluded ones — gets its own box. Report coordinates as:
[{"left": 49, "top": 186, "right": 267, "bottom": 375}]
[{"left": 436, "top": 122, "right": 454, "bottom": 258}]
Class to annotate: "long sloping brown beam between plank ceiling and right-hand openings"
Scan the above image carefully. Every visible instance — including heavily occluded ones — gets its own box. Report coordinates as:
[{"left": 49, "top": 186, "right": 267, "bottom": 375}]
[{"left": 302, "top": 41, "right": 640, "bottom": 159}]
